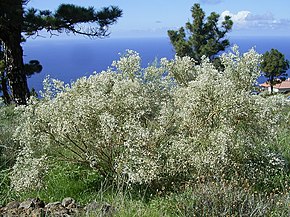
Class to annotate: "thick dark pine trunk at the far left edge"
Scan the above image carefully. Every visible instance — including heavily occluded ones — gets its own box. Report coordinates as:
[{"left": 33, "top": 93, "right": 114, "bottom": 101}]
[{"left": 0, "top": 0, "right": 29, "bottom": 105}]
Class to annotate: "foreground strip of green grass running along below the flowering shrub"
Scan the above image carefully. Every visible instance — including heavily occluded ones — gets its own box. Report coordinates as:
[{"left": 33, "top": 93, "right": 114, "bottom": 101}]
[{"left": 3, "top": 163, "right": 290, "bottom": 217}]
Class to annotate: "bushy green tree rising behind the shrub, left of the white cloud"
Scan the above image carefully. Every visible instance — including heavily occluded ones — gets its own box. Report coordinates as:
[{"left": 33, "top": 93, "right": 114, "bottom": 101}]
[{"left": 168, "top": 4, "right": 233, "bottom": 64}]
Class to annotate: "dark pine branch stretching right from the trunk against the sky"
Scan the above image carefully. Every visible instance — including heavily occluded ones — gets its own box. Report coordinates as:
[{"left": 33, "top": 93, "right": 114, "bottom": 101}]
[{"left": 23, "top": 4, "right": 122, "bottom": 37}]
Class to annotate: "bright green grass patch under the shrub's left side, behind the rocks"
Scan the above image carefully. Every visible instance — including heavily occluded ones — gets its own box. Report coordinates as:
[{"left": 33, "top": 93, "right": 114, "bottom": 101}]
[{"left": 19, "top": 163, "right": 102, "bottom": 204}]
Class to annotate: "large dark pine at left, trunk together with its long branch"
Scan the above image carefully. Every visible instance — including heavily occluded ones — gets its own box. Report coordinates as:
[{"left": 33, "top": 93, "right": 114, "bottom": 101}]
[{"left": 0, "top": 0, "right": 122, "bottom": 104}]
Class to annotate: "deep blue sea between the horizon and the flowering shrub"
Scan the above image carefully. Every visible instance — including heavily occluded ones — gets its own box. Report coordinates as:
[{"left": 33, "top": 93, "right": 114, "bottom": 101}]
[{"left": 23, "top": 36, "right": 290, "bottom": 91}]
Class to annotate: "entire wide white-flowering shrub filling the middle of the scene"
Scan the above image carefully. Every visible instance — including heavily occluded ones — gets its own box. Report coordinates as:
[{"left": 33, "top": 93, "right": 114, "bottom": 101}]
[{"left": 13, "top": 47, "right": 285, "bottom": 190}]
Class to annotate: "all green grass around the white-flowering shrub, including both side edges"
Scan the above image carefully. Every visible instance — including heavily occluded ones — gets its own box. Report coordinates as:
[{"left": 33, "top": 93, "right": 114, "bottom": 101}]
[{"left": 0, "top": 104, "right": 290, "bottom": 217}]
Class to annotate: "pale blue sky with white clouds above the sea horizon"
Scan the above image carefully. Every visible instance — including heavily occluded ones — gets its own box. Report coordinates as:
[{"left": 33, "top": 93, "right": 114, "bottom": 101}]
[{"left": 27, "top": 0, "right": 290, "bottom": 38}]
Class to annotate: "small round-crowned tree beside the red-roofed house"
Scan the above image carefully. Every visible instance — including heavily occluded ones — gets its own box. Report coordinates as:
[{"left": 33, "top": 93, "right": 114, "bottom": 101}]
[{"left": 261, "top": 49, "right": 289, "bottom": 93}]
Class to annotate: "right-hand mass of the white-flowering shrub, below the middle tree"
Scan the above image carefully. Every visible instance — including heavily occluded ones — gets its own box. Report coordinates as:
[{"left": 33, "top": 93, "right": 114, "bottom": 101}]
[{"left": 166, "top": 47, "right": 285, "bottom": 181}]
